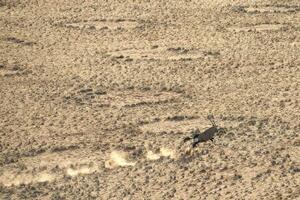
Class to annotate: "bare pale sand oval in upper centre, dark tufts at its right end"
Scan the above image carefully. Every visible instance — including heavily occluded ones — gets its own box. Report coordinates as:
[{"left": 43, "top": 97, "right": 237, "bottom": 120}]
[{"left": 108, "top": 46, "right": 219, "bottom": 60}]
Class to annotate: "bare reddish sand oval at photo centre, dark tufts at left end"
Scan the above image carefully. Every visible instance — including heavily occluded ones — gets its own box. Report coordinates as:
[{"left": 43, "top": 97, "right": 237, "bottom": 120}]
[{"left": 65, "top": 89, "right": 180, "bottom": 108}]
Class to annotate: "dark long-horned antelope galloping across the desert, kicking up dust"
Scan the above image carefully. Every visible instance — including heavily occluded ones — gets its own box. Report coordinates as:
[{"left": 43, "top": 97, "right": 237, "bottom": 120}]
[{"left": 183, "top": 115, "right": 224, "bottom": 148}]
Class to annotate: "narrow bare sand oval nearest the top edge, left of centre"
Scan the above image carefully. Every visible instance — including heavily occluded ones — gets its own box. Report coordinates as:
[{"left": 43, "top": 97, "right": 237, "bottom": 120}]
[{"left": 65, "top": 19, "right": 140, "bottom": 30}]
